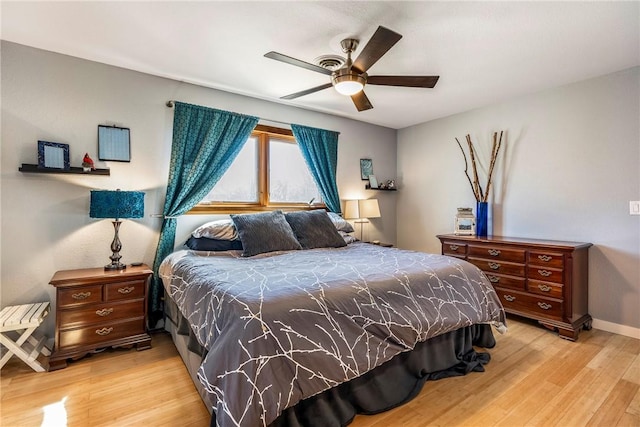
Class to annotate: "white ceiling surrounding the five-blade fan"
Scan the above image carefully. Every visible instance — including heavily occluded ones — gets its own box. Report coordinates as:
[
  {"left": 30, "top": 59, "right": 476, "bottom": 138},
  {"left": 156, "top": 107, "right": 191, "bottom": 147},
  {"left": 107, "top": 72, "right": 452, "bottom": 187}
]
[{"left": 1, "top": 1, "right": 640, "bottom": 129}]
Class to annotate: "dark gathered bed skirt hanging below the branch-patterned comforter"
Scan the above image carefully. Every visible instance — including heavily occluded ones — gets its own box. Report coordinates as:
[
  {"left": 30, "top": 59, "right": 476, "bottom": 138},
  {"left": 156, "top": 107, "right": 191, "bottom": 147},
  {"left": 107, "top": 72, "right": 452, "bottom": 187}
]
[{"left": 165, "top": 300, "right": 495, "bottom": 427}]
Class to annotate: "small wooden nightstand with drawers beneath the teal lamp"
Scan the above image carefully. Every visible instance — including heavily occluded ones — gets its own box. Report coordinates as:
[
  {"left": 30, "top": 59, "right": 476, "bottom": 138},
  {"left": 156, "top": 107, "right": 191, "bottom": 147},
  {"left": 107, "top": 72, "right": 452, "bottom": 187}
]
[{"left": 49, "top": 265, "right": 152, "bottom": 371}]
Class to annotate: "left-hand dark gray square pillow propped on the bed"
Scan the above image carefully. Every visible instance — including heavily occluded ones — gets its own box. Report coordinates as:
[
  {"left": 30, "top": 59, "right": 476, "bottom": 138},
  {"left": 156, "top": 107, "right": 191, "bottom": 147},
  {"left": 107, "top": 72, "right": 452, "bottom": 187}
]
[{"left": 231, "top": 211, "right": 302, "bottom": 257}]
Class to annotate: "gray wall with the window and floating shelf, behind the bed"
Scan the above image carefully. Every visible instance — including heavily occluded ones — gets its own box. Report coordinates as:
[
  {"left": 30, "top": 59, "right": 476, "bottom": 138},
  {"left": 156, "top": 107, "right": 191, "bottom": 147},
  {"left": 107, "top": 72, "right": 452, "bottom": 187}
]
[{"left": 0, "top": 41, "right": 396, "bottom": 336}]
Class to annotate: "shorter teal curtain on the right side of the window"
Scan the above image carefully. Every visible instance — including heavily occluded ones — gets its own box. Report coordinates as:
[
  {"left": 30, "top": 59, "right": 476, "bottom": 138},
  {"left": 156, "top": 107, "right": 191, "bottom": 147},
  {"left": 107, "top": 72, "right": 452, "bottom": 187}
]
[{"left": 291, "top": 125, "right": 342, "bottom": 213}]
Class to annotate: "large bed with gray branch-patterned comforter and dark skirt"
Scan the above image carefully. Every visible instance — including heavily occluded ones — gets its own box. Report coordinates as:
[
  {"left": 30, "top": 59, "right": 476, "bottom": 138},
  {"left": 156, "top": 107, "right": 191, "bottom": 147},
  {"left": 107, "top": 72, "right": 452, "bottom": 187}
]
[{"left": 159, "top": 214, "right": 505, "bottom": 427}]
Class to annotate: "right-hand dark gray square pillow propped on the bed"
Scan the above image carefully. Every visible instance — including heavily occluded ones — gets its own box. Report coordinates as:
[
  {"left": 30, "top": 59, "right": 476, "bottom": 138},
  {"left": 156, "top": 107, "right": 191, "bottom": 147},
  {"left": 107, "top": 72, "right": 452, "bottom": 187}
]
[{"left": 284, "top": 209, "right": 347, "bottom": 249}]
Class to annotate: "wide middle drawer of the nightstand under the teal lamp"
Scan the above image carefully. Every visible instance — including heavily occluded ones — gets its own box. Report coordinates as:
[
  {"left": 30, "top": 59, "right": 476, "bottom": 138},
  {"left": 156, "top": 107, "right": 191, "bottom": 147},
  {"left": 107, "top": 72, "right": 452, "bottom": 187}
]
[{"left": 58, "top": 300, "right": 144, "bottom": 328}]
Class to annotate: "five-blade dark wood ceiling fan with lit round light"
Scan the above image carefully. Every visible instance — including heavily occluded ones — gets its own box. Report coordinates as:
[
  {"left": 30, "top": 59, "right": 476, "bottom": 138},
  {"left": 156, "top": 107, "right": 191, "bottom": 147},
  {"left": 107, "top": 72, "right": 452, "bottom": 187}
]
[{"left": 264, "top": 26, "right": 440, "bottom": 111}]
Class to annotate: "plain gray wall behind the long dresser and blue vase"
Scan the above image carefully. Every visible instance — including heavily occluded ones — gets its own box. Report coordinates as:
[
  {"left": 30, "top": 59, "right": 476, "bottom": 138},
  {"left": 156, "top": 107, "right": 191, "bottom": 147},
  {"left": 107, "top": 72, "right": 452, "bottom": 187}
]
[{"left": 398, "top": 67, "right": 640, "bottom": 336}]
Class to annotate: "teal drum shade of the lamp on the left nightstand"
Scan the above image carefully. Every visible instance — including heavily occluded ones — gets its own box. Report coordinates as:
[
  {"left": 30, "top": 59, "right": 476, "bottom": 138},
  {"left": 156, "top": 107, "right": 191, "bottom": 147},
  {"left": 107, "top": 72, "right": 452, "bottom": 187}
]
[{"left": 89, "top": 190, "right": 144, "bottom": 220}]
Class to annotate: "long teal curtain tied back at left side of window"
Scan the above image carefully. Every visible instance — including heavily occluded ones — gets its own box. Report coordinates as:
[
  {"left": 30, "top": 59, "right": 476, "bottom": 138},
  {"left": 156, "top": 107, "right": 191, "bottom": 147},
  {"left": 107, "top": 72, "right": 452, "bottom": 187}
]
[{"left": 149, "top": 102, "right": 258, "bottom": 325}]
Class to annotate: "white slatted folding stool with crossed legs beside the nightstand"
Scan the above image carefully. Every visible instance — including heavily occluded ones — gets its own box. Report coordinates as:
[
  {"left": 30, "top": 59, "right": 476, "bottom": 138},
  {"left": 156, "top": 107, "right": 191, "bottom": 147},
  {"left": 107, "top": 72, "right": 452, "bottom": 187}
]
[{"left": 0, "top": 302, "right": 51, "bottom": 372}]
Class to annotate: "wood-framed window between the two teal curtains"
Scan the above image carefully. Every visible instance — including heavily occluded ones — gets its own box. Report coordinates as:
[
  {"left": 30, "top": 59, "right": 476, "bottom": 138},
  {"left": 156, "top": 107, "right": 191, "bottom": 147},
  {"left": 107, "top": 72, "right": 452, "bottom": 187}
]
[{"left": 191, "top": 125, "right": 324, "bottom": 213}]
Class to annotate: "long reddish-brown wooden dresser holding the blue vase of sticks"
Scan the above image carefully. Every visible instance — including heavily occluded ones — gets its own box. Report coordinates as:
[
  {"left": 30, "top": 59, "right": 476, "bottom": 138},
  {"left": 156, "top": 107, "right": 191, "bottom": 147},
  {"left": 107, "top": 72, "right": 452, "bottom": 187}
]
[{"left": 437, "top": 234, "right": 592, "bottom": 341}]
